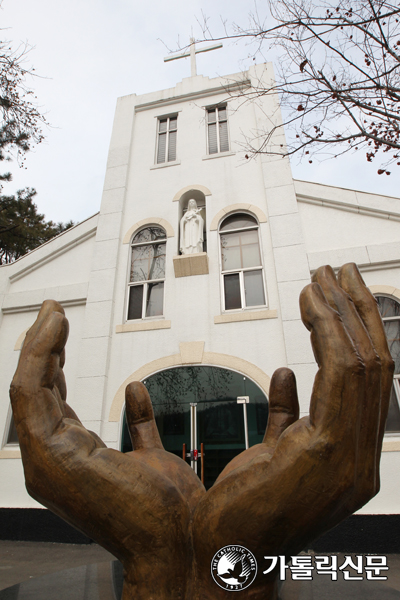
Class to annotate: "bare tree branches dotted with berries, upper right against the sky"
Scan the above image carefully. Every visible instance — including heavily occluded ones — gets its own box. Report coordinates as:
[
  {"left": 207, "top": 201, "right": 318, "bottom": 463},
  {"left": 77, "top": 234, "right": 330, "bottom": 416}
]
[{"left": 198, "top": 0, "right": 400, "bottom": 174}]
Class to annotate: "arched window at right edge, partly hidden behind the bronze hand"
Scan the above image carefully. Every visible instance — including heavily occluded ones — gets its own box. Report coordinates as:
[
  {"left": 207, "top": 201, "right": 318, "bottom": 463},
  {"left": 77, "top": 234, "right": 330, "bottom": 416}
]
[{"left": 375, "top": 296, "right": 400, "bottom": 433}]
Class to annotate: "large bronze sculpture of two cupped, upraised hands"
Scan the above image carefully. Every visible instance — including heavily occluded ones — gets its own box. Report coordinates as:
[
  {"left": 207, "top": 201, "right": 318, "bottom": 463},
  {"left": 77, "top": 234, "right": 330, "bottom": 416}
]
[{"left": 11, "top": 265, "right": 393, "bottom": 600}]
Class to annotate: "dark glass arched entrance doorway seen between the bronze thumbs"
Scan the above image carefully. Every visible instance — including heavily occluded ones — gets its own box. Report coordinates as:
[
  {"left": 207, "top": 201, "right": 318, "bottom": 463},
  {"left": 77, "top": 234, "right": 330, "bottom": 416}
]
[{"left": 121, "top": 365, "right": 268, "bottom": 488}]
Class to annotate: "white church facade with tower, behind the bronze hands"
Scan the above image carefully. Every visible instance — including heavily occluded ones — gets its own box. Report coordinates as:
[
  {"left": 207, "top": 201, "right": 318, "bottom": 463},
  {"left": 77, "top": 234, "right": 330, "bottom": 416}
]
[{"left": 0, "top": 64, "right": 400, "bottom": 540}]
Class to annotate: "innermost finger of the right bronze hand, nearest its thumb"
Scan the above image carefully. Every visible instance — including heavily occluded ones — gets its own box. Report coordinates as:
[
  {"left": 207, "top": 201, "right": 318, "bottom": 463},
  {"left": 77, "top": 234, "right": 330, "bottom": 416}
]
[{"left": 300, "top": 283, "right": 365, "bottom": 441}]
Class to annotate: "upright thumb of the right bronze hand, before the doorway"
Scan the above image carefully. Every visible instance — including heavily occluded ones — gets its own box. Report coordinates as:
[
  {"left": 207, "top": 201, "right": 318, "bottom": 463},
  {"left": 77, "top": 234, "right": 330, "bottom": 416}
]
[{"left": 263, "top": 368, "right": 299, "bottom": 449}]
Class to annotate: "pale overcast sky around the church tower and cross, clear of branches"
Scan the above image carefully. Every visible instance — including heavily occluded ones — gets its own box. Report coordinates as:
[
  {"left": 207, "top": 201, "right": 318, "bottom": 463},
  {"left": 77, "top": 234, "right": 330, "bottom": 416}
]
[{"left": 0, "top": 0, "right": 400, "bottom": 221}]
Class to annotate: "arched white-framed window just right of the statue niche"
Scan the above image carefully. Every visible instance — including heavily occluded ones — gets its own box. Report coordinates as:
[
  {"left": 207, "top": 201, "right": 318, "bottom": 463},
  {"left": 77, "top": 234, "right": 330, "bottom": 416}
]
[{"left": 219, "top": 213, "right": 266, "bottom": 310}]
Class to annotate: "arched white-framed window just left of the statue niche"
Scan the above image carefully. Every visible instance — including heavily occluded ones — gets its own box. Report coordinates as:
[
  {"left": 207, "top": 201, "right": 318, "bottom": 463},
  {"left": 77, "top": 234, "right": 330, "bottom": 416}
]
[{"left": 127, "top": 227, "right": 166, "bottom": 320}]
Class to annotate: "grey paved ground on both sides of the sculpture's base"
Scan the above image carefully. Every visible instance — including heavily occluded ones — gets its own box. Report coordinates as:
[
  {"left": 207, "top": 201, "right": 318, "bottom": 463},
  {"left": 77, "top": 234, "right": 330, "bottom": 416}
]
[{"left": 0, "top": 541, "right": 400, "bottom": 600}]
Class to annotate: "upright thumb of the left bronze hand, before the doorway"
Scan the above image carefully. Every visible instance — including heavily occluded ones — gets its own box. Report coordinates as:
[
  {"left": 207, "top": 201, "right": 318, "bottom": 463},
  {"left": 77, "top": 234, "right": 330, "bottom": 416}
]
[{"left": 125, "top": 381, "right": 163, "bottom": 450}]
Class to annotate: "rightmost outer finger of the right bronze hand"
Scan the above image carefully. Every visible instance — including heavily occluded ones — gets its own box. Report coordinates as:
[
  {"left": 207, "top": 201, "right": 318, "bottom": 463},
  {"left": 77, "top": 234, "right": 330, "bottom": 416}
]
[{"left": 338, "top": 263, "right": 394, "bottom": 461}]
